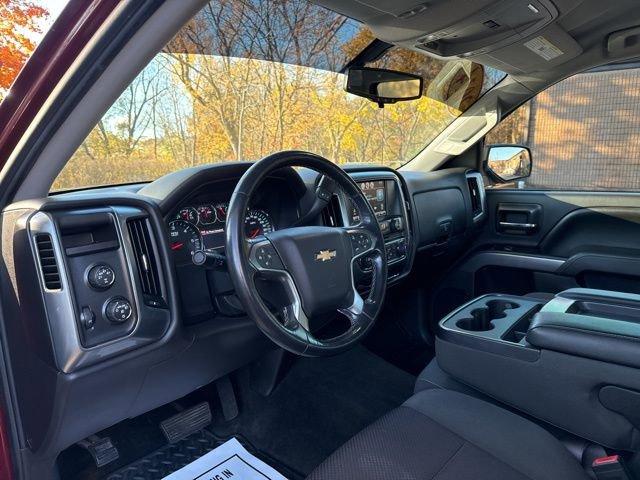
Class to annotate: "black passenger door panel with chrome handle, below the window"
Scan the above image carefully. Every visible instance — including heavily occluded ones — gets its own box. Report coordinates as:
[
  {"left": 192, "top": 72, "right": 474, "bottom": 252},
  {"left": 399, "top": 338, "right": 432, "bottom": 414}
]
[{"left": 433, "top": 189, "right": 640, "bottom": 319}]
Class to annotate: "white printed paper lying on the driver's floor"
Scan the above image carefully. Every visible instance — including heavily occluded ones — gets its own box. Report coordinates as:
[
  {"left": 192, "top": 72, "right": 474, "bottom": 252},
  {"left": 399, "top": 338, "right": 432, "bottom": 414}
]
[{"left": 163, "top": 438, "right": 287, "bottom": 480}]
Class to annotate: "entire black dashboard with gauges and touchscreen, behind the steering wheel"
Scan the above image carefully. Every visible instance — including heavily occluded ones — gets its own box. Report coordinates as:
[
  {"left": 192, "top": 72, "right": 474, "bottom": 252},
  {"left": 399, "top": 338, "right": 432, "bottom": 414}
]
[{"left": 1, "top": 162, "right": 483, "bottom": 464}]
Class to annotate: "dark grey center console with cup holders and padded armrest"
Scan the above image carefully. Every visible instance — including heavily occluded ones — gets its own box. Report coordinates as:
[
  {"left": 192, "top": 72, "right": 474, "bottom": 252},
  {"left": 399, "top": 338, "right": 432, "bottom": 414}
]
[{"left": 436, "top": 289, "right": 640, "bottom": 451}]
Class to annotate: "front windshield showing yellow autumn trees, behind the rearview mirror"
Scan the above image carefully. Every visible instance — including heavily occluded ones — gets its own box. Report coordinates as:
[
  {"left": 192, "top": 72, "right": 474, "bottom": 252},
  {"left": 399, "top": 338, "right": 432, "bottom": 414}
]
[{"left": 53, "top": 0, "right": 504, "bottom": 190}]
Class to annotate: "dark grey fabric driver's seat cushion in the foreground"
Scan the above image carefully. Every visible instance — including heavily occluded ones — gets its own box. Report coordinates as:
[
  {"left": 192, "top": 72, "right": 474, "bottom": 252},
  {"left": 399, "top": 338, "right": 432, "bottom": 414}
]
[{"left": 308, "top": 389, "right": 589, "bottom": 480}]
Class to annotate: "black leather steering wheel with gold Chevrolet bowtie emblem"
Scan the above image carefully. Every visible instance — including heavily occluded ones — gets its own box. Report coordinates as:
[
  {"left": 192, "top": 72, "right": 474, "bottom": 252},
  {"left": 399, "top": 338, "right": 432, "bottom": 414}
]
[{"left": 226, "top": 151, "right": 387, "bottom": 356}]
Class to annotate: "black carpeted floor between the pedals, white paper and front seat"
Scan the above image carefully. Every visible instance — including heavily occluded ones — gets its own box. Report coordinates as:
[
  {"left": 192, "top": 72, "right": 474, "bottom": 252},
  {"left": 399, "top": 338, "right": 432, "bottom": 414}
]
[{"left": 210, "top": 347, "right": 415, "bottom": 478}]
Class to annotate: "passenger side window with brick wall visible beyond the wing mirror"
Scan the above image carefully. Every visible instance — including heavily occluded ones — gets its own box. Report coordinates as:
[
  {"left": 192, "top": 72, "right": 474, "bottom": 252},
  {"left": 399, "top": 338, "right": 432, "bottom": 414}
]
[{"left": 485, "top": 68, "right": 640, "bottom": 191}]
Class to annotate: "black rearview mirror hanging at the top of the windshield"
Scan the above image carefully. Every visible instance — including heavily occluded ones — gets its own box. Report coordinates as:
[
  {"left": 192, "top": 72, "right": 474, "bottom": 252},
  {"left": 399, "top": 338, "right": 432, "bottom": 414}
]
[{"left": 345, "top": 67, "right": 424, "bottom": 107}]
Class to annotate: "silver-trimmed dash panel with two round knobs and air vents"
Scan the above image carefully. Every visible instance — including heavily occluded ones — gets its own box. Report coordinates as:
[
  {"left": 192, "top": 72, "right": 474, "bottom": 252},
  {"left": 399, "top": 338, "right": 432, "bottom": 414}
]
[{"left": 28, "top": 206, "right": 170, "bottom": 373}]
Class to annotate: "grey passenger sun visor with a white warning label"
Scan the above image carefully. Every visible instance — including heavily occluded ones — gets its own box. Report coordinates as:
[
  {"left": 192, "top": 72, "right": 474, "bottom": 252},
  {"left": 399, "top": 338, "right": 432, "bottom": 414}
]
[{"left": 471, "top": 25, "right": 582, "bottom": 75}]
